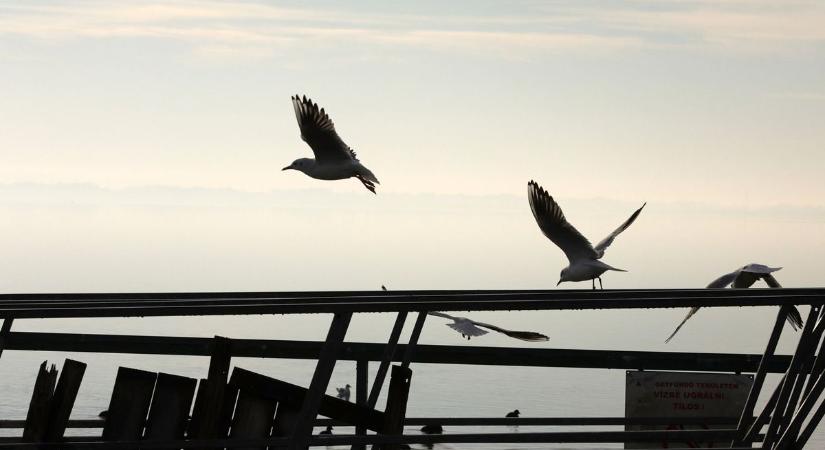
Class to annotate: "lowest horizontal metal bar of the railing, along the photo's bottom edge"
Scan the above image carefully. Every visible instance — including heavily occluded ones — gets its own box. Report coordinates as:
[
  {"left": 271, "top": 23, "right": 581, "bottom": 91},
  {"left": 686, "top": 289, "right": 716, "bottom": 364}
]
[{"left": 0, "top": 429, "right": 752, "bottom": 450}]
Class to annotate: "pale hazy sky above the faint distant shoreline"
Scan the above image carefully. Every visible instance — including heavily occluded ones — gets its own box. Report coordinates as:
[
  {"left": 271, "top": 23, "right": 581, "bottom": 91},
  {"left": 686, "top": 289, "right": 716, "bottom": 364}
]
[{"left": 0, "top": 0, "right": 825, "bottom": 206}]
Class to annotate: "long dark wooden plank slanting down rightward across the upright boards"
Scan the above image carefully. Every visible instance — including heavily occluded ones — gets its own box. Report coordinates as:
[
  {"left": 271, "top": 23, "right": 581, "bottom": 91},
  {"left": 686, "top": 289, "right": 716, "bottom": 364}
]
[{"left": 229, "top": 367, "right": 384, "bottom": 431}]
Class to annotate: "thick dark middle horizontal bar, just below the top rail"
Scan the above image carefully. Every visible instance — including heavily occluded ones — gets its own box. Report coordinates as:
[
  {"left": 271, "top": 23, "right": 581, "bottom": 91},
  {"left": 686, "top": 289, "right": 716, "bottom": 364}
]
[{"left": 0, "top": 331, "right": 791, "bottom": 373}]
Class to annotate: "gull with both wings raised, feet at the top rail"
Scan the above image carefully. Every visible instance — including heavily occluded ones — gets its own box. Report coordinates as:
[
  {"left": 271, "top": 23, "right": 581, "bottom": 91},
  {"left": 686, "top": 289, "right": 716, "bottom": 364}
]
[{"left": 527, "top": 180, "right": 647, "bottom": 289}]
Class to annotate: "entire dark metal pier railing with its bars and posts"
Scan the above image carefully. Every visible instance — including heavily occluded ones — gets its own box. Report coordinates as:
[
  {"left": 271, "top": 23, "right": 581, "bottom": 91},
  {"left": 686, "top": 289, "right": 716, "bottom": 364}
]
[{"left": 0, "top": 288, "right": 825, "bottom": 449}]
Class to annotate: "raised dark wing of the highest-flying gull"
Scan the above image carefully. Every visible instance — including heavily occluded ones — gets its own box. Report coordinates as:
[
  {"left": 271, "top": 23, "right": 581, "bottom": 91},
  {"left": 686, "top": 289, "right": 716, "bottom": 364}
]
[{"left": 292, "top": 95, "right": 358, "bottom": 163}]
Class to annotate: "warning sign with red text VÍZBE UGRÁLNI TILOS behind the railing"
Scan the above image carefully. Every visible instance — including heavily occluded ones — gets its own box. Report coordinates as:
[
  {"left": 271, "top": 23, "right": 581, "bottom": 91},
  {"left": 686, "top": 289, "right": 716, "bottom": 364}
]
[{"left": 625, "top": 371, "right": 753, "bottom": 448}]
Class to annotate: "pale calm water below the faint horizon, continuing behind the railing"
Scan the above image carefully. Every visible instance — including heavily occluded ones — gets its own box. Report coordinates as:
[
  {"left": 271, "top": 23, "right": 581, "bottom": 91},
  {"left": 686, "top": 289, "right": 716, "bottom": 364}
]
[{"left": 0, "top": 189, "right": 825, "bottom": 448}]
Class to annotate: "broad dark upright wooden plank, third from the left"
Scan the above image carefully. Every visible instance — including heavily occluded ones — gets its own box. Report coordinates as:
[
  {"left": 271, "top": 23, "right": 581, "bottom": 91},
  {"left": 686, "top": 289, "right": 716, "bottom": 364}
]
[{"left": 103, "top": 367, "right": 158, "bottom": 441}]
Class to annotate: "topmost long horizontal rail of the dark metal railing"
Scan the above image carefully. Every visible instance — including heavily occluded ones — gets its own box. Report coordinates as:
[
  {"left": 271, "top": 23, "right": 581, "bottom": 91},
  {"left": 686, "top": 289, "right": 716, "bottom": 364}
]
[{"left": 0, "top": 288, "right": 825, "bottom": 318}]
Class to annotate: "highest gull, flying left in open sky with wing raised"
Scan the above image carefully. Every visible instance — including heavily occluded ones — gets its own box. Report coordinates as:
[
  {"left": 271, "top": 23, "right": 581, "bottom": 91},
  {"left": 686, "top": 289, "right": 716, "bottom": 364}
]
[{"left": 281, "top": 95, "right": 379, "bottom": 194}]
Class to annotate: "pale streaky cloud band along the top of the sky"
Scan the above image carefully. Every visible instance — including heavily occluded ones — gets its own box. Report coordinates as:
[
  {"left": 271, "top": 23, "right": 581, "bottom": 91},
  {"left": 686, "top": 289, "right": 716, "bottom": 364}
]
[{"left": 0, "top": 0, "right": 825, "bottom": 57}]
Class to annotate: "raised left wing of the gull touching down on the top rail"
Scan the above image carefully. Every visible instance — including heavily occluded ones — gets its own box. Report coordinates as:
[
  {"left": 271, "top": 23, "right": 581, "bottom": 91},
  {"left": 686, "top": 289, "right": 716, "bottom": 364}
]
[{"left": 527, "top": 180, "right": 598, "bottom": 263}]
